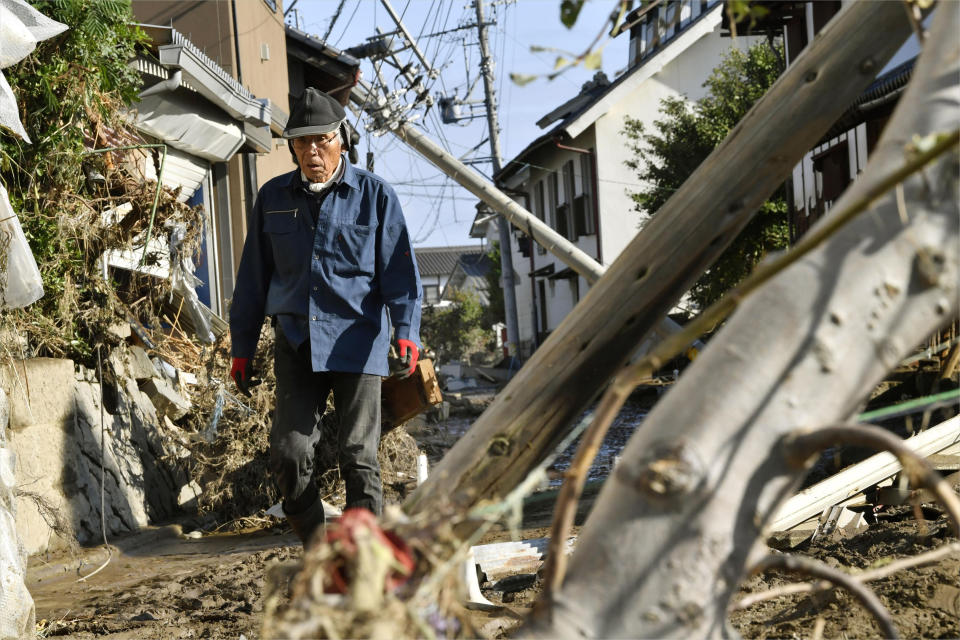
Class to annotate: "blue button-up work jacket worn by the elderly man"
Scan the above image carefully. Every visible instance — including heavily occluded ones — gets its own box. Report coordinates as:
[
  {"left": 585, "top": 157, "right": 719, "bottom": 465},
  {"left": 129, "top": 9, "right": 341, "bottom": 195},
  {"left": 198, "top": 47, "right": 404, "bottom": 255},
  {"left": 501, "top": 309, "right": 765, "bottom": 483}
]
[{"left": 230, "top": 158, "right": 422, "bottom": 376}]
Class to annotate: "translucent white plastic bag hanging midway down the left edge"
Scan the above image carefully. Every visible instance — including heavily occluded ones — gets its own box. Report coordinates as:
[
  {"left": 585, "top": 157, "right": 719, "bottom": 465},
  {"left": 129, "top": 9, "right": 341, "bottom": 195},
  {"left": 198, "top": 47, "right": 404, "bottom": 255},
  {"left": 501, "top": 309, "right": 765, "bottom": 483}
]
[{"left": 0, "top": 185, "right": 43, "bottom": 308}]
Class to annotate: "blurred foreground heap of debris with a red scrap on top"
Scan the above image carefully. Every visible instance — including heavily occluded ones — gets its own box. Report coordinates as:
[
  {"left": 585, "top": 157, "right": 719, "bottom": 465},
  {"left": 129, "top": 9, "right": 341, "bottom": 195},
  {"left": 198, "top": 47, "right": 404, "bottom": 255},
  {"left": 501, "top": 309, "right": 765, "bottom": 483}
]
[{"left": 263, "top": 508, "right": 478, "bottom": 639}]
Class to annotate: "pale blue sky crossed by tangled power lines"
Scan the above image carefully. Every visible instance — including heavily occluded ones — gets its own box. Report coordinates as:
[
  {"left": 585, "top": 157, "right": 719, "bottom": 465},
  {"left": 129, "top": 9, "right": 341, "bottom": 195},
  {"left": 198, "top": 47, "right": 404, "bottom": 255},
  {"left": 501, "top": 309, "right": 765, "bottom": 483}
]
[{"left": 284, "top": 0, "right": 628, "bottom": 247}]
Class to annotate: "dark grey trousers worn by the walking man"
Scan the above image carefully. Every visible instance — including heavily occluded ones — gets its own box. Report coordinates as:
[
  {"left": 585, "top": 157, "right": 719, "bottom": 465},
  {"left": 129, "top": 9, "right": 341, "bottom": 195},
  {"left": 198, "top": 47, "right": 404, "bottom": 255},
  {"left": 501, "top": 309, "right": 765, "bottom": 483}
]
[{"left": 270, "top": 327, "right": 383, "bottom": 515}]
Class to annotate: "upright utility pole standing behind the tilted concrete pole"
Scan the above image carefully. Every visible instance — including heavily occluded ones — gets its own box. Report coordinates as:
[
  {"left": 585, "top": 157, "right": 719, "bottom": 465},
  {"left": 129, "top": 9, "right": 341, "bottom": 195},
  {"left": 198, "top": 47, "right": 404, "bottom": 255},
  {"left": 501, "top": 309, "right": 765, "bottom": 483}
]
[{"left": 474, "top": 0, "right": 520, "bottom": 358}]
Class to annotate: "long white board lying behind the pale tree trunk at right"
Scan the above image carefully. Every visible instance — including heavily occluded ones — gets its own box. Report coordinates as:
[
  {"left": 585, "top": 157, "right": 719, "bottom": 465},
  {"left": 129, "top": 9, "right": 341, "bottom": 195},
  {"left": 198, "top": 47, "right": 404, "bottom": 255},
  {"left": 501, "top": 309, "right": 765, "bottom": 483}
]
[{"left": 770, "top": 416, "right": 960, "bottom": 531}]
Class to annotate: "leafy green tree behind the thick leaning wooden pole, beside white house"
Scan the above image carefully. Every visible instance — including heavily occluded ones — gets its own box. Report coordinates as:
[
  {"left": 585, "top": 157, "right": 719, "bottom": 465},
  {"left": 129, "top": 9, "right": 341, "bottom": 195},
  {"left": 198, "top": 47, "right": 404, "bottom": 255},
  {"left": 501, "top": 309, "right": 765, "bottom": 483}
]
[{"left": 623, "top": 43, "right": 789, "bottom": 306}]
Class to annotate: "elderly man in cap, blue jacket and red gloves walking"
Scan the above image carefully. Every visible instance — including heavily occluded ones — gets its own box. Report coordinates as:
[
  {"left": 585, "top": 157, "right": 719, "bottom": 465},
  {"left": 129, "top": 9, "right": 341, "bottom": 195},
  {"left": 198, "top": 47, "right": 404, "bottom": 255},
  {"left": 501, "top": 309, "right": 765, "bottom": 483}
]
[{"left": 230, "top": 88, "right": 421, "bottom": 544}]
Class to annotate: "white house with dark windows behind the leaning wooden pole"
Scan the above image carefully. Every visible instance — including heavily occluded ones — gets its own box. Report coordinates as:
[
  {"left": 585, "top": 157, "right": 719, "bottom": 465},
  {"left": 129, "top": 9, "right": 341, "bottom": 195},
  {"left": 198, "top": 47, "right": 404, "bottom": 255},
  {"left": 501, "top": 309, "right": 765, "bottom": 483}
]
[{"left": 488, "top": 0, "right": 755, "bottom": 356}]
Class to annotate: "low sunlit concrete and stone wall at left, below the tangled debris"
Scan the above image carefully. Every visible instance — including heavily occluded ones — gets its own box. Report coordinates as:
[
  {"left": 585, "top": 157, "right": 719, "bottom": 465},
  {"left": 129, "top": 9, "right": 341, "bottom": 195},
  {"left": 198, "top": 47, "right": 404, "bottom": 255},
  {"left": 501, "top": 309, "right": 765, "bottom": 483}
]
[{"left": 0, "top": 347, "right": 187, "bottom": 554}]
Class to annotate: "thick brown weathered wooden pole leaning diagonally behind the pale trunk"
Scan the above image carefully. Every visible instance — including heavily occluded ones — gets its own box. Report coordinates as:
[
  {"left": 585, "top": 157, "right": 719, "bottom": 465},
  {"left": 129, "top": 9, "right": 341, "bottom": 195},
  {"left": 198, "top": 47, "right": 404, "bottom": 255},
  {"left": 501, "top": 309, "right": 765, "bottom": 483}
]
[{"left": 404, "top": 2, "right": 911, "bottom": 513}]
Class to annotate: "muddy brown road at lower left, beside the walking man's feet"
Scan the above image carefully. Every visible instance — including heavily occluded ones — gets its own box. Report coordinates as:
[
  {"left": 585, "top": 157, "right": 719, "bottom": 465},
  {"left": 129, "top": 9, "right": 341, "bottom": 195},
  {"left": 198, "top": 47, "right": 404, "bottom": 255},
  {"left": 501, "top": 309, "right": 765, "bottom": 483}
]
[{"left": 27, "top": 525, "right": 301, "bottom": 640}]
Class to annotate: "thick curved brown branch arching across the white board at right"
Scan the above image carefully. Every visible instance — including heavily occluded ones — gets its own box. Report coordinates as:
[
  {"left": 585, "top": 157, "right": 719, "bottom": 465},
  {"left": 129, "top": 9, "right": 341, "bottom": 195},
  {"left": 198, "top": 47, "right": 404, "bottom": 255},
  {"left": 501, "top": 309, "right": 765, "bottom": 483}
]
[{"left": 783, "top": 424, "right": 960, "bottom": 535}]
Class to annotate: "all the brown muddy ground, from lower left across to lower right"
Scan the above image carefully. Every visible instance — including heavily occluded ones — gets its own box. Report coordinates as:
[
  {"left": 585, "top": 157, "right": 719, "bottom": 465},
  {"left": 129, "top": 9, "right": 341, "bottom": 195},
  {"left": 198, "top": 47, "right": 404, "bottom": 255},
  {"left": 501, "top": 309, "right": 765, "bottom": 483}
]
[{"left": 27, "top": 392, "right": 960, "bottom": 640}]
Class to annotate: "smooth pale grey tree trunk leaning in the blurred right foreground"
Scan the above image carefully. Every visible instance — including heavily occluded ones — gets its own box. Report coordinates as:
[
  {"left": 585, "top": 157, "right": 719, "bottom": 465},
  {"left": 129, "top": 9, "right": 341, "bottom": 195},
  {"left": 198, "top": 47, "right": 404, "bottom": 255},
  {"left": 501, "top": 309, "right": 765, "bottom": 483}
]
[{"left": 525, "top": 2, "right": 960, "bottom": 640}]
